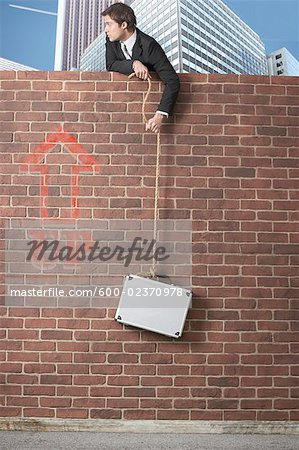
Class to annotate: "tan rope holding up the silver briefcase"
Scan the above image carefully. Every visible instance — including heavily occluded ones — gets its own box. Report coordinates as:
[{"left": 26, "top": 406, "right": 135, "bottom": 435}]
[{"left": 129, "top": 73, "right": 161, "bottom": 278}]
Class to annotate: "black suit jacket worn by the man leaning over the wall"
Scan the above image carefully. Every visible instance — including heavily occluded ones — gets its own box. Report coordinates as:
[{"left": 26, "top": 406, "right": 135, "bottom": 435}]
[{"left": 106, "top": 28, "right": 180, "bottom": 114}]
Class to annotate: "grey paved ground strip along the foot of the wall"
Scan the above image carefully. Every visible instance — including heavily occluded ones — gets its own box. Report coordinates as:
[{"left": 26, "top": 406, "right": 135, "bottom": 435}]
[{"left": 0, "top": 431, "right": 299, "bottom": 450}]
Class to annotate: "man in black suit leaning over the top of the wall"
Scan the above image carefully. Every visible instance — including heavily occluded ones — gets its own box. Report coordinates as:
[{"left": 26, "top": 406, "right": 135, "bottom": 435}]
[{"left": 101, "top": 3, "right": 180, "bottom": 133}]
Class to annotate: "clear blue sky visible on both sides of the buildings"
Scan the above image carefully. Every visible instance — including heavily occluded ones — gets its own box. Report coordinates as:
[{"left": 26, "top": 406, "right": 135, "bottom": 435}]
[{"left": 0, "top": 0, "right": 299, "bottom": 70}]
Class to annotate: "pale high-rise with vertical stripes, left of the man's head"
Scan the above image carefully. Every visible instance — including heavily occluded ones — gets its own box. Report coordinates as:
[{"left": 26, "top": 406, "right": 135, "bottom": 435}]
[{"left": 54, "top": 0, "right": 130, "bottom": 70}]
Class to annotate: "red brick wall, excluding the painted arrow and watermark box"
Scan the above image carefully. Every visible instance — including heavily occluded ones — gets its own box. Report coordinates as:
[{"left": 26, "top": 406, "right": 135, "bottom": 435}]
[{"left": 0, "top": 72, "right": 299, "bottom": 420}]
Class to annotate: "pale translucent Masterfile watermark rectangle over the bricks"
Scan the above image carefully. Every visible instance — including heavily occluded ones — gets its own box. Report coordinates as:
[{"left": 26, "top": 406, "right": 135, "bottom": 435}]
[{"left": 5, "top": 218, "right": 192, "bottom": 308}]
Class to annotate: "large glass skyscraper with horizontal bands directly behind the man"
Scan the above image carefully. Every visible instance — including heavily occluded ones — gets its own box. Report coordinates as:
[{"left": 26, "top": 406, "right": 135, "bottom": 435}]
[{"left": 80, "top": 0, "right": 268, "bottom": 75}]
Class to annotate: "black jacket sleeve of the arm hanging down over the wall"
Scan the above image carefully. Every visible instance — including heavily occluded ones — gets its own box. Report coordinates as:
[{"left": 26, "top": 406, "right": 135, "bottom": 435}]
[{"left": 149, "top": 40, "right": 180, "bottom": 114}]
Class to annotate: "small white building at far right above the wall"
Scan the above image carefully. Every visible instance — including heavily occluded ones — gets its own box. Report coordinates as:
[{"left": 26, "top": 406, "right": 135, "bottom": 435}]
[{"left": 267, "top": 48, "right": 299, "bottom": 76}]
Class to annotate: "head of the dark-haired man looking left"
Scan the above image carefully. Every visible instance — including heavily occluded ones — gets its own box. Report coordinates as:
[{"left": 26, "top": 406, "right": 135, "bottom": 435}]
[{"left": 101, "top": 3, "right": 136, "bottom": 41}]
